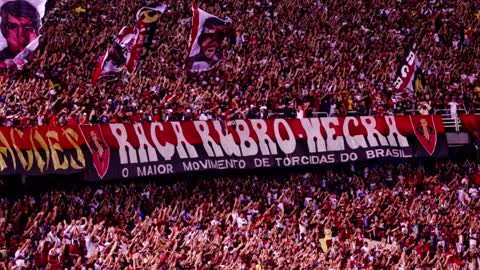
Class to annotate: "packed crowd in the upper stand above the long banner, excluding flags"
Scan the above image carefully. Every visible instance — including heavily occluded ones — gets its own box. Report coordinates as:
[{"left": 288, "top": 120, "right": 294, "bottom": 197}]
[{"left": 0, "top": 0, "right": 480, "bottom": 127}]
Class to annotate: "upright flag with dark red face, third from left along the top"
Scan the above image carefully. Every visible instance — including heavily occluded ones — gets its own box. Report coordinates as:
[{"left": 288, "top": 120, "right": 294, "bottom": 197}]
[{"left": 186, "top": 2, "right": 231, "bottom": 72}]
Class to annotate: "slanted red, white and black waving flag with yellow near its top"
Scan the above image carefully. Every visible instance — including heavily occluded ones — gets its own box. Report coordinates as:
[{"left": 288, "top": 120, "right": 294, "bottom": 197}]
[{"left": 92, "top": 5, "right": 166, "bottom": 84}]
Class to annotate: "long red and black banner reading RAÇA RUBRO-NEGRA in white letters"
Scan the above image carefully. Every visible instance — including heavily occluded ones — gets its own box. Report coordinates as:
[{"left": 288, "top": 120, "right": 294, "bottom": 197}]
[{"left": 80, "top": 116, "right": 448, "bottom": 179}]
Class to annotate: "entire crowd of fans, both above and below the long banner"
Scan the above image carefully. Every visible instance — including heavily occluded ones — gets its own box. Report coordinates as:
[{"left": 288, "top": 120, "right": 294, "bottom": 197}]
[{"left": 0, "top": 0, "right": 480, "bottom": 270}]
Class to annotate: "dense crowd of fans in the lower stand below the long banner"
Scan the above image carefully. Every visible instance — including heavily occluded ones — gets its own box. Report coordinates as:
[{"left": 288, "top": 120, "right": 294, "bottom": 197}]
[{"left": 0, "top": 161, "right": 480, "bottom": 270}]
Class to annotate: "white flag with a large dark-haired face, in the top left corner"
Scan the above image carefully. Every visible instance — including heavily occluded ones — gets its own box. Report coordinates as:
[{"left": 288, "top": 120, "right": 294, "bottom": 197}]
[{"left": 0, "top": 0, "right": 47, "bottom": 69}]
